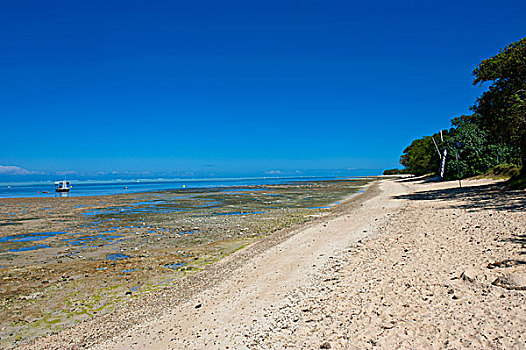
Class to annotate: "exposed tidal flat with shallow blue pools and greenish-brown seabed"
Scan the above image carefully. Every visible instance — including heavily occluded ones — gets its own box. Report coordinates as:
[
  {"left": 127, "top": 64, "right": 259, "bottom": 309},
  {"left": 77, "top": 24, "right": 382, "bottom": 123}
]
[{"left": 0, "top": 179, "right": 370, "bottom": 347}]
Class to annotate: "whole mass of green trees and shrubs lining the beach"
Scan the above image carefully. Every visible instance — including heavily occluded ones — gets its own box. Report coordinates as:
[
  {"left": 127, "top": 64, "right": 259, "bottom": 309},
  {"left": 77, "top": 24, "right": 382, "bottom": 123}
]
[{"left": 394, "top": 38, "right": 526, "bottom": 179}]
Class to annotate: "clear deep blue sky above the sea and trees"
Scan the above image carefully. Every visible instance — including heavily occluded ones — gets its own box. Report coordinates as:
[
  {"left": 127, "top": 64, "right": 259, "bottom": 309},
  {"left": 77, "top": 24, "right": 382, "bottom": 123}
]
[{"left": 0, "top": 0, "right": 526, "bottom": 179}]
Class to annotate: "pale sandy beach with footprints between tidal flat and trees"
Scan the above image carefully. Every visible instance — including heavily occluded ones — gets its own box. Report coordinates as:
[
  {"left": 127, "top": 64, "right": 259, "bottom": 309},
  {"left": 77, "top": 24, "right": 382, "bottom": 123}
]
[{"left": 15, "top": 179, "right": 526, "bottom": 349}]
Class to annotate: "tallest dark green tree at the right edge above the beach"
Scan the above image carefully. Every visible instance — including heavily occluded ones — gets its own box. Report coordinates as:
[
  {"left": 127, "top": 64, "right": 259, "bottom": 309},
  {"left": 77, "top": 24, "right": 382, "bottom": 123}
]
[{"left": 472, "top": 38, "right": 526, "bottom": 175}]
